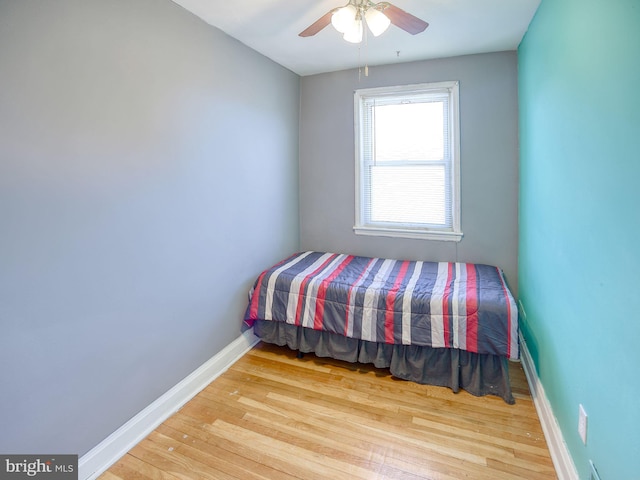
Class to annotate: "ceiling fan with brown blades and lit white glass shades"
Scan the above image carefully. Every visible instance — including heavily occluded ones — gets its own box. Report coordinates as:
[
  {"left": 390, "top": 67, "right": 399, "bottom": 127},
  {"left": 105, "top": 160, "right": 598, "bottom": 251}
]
[{"left": 299, "top": 0, "right": 429, "bottom": 43}]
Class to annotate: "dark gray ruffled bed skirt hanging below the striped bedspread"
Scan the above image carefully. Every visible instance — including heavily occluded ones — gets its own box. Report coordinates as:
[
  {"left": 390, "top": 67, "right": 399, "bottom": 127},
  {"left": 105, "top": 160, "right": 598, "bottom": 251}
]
[{"left": 254, "top": 320, "right": 515, "bottom": 404}]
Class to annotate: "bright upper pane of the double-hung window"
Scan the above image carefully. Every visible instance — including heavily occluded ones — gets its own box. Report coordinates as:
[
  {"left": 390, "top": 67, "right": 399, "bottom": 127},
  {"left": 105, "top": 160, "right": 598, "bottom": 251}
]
[{"left": 373, "top": 102, "right": 445, "bottom": 161}]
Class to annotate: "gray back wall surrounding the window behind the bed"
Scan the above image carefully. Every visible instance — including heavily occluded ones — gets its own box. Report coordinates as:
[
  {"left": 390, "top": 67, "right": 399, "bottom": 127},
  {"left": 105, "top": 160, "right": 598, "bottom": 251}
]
[{"left": 300, "top": 52, "right": 518, "bottom": 294}]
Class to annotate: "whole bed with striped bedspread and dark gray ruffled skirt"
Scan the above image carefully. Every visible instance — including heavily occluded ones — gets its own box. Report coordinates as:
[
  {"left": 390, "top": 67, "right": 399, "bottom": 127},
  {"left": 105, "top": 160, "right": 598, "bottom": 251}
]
[{"left": 244, "top": 251, "right": 519, "bottom": 404}]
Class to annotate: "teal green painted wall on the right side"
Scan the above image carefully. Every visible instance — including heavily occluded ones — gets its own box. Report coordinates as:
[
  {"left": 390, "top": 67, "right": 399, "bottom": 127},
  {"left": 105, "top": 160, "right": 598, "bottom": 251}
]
[{"left": 518, "top": 0, "right": 640, "bottom": 480}]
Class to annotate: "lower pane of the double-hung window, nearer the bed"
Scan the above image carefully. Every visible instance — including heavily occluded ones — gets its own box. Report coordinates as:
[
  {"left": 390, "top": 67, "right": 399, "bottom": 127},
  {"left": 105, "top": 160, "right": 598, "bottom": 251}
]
[{"left": 370, "top": 165, "right": 450, "bottom": 226}]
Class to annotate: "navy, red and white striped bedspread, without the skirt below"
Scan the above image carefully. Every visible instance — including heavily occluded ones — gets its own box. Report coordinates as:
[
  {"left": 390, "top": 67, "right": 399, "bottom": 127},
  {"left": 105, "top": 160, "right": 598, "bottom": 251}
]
[{"left": 245, "top": 252, "right": 519, "bottom": 359}]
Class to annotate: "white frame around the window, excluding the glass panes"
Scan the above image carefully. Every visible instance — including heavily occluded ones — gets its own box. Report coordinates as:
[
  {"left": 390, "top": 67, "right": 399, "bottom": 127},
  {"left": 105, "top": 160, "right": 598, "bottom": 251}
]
[{"left": 353, "top": 81, "right": 463, "bottom": 242}]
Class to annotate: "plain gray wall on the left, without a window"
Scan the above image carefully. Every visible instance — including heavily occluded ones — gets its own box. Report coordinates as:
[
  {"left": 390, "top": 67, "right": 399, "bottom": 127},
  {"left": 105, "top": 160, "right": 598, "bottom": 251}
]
[{"left": 0, "top": 0, "right": 299, "bottom": 455}]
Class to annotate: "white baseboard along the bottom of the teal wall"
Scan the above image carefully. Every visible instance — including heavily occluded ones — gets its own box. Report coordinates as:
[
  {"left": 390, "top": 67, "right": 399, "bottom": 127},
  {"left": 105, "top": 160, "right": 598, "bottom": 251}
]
[{"left": 520, "top": 334, "right": 579, "bottom": 480}]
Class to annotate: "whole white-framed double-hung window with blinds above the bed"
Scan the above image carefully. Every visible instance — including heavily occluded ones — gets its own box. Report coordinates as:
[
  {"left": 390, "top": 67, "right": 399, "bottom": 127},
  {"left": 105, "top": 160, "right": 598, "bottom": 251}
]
[{"left": 354, "top": 82, "right": 462, "bottom": 241}]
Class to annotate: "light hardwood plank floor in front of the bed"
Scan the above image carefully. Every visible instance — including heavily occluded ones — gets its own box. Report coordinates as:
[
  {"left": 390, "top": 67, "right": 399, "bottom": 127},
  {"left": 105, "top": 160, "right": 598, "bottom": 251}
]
[{"left": 100, "top": 343, "right": 556, "bottom": 480}]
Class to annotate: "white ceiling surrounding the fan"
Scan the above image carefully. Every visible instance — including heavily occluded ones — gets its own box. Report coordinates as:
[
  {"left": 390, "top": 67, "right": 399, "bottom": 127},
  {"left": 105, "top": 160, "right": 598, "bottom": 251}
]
[{"left": 173, "top": 0, "right": 540, "bottom": 76}]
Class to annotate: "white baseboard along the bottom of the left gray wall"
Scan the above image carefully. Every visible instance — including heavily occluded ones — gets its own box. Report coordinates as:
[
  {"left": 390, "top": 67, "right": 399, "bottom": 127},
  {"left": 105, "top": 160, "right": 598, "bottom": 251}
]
[{"left": 78, "top": 330, "right": 259, "bottom": 480}]
